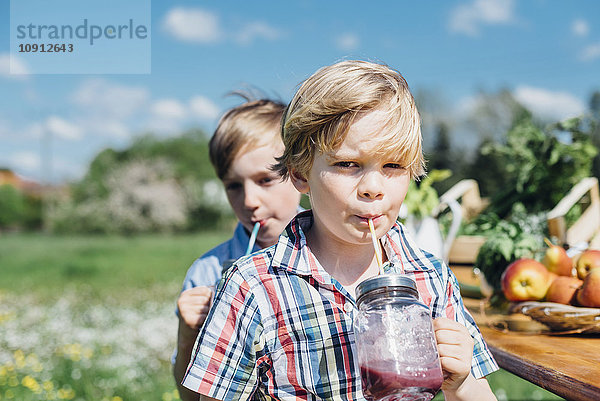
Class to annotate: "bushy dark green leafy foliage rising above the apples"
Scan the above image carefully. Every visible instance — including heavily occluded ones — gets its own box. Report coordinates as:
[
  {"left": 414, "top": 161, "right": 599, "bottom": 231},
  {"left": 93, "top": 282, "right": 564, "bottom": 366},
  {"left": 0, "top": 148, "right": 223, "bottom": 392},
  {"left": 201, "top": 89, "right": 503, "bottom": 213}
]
[{"left": 474, "top": 118, "right": 598, "bottom": 218}]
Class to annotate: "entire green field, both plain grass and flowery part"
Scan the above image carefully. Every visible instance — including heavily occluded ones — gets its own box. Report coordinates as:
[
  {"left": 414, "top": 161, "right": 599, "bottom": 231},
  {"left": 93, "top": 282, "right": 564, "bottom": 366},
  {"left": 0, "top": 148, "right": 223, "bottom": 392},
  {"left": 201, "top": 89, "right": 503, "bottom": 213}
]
[{"left": 0, "top": 232, "right": 561, "bottom": 401}]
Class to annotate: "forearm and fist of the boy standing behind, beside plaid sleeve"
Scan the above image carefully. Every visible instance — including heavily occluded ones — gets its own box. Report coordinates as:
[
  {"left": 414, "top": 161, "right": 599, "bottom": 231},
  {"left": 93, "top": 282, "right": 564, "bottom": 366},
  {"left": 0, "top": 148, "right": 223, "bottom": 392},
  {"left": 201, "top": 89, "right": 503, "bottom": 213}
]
[{"left": 173, "top": 287, "right": 212, "bottom": 401}]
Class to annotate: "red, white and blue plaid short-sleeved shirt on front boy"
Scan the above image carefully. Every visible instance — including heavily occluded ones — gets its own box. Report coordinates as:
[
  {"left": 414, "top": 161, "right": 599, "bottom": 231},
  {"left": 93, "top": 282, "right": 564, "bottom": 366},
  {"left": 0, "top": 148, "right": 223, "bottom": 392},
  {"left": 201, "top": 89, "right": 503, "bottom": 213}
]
[{"left": 183, "top": 211, "right": 498, "bottom": 400}]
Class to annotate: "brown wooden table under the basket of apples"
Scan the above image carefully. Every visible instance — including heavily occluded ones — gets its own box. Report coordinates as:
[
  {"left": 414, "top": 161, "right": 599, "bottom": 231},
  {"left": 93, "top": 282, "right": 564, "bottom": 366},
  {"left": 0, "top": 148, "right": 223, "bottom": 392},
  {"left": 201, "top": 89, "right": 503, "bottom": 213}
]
[{"left": 452, "top": 268, "right": 600, "bottom": 401}]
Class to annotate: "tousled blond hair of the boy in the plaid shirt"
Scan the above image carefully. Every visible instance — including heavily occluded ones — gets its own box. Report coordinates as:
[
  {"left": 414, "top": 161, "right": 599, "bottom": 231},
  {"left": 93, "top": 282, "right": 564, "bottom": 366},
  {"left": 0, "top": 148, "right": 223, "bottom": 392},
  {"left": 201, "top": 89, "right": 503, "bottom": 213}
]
[{"left": 273, "top": 60, "right": 425, "bottom": 179}]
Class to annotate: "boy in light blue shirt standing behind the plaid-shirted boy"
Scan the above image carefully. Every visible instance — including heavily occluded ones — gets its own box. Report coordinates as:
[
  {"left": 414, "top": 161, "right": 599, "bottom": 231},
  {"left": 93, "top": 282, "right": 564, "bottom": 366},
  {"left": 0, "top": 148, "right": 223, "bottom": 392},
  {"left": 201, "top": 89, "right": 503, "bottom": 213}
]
[{"left": 174, "top": 99, "right": 300, "bottom": 400}]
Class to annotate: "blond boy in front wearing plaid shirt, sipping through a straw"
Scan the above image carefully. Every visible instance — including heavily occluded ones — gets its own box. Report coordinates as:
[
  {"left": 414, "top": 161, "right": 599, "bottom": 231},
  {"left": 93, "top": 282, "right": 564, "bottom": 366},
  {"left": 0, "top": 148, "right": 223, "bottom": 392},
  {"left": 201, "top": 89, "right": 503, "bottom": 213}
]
[{"left": 183, "top": 61, "right": 498, "bottom": 400}]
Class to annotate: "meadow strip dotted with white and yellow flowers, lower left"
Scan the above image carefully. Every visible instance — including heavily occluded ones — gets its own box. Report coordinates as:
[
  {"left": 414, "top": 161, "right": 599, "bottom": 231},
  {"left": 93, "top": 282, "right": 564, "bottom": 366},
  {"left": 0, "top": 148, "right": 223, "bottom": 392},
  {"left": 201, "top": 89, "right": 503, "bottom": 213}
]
[{"left": 0, "top": 293, "right": 179, "bottom": 401}]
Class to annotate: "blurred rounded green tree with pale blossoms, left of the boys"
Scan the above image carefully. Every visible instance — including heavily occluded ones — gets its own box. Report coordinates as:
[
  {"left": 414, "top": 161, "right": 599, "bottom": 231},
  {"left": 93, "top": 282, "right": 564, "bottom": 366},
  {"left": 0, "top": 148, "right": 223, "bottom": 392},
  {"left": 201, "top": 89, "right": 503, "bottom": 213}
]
[{"left": 51, "top": 130, "right": 232, "bottom": 233}]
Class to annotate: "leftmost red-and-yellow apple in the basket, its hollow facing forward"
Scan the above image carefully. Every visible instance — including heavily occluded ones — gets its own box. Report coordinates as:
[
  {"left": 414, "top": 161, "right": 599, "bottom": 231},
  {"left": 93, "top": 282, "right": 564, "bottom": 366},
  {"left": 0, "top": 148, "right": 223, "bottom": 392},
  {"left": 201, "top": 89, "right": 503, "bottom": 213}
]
[{"left": 500, "top": 258, "right": 550, "bottom": 301}]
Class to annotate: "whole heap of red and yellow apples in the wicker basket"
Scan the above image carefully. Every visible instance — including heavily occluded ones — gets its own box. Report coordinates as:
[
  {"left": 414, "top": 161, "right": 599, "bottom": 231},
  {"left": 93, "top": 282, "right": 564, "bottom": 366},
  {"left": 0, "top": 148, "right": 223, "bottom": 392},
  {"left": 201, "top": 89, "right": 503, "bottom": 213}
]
[{"left": 501, "top": 241, "right": 600, "bottom": 308}]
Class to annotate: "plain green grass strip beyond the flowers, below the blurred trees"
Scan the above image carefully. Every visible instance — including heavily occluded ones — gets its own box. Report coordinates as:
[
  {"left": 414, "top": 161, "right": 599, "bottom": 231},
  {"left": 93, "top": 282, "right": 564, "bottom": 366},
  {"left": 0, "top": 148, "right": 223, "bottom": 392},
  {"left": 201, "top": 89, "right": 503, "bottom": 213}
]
[{"left": 0, "top": 232, "right": 229, "bottom": 301}]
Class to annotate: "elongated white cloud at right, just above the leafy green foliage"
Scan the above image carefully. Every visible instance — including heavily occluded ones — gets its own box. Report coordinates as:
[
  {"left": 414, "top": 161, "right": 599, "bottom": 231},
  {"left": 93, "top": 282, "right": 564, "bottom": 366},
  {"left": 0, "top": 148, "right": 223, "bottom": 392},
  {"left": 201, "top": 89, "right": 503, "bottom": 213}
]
[{"left": 514, "top": 86, "right": 585, "bottom": 120}]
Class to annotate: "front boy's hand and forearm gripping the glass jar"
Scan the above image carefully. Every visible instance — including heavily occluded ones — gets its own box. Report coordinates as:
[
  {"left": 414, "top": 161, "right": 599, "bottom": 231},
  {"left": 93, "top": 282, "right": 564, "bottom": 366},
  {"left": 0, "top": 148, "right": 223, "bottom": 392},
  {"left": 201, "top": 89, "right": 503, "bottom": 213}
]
[{"left": 433, "top": 317, "right": 496, "bottom": 401}]
